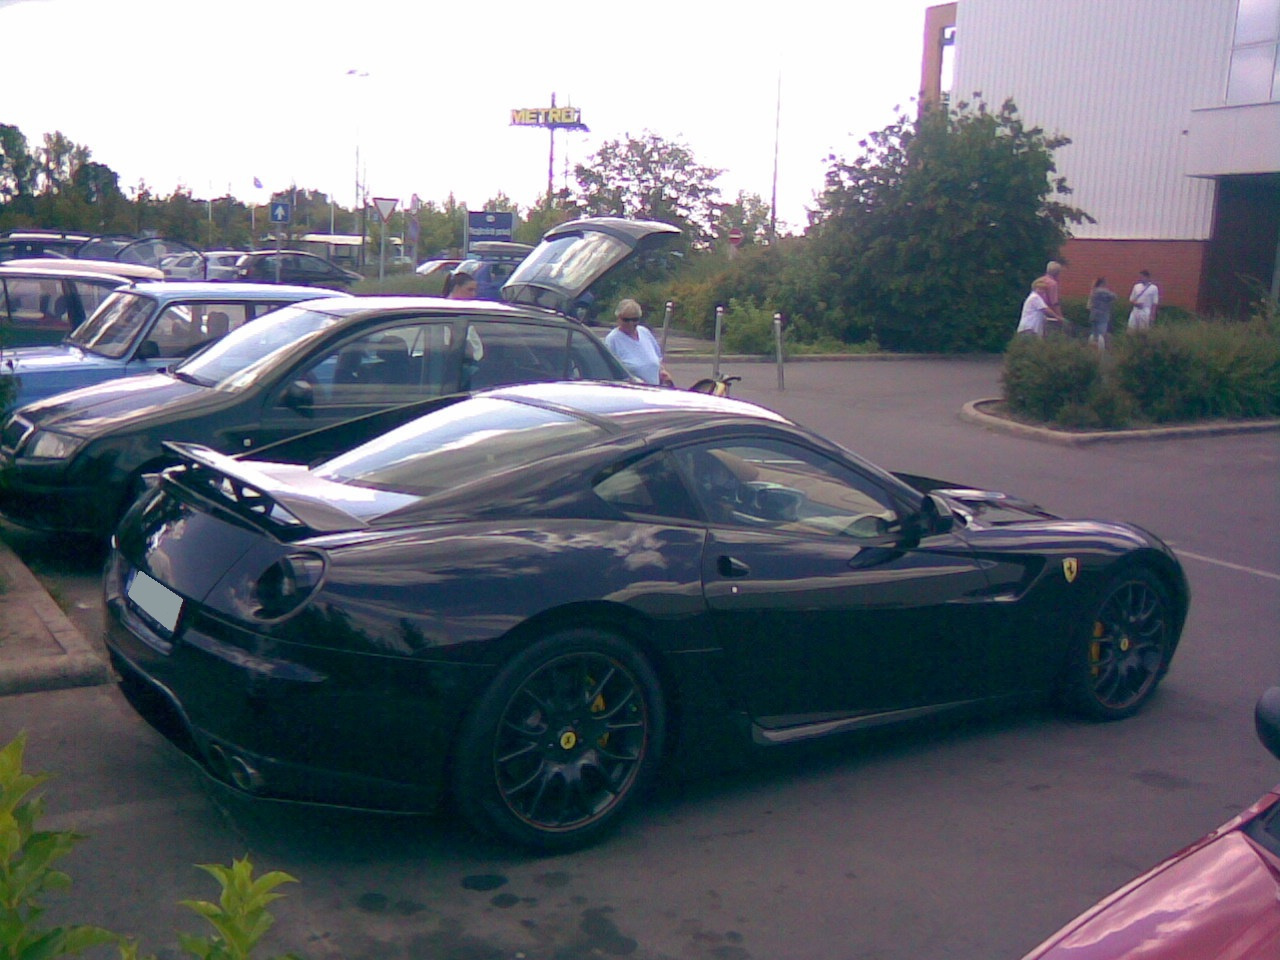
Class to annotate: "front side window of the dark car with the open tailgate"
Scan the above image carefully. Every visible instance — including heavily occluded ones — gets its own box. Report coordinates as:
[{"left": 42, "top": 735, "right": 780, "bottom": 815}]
[{"left": 296, "top": 323, "right": 453, "bottom": 406}]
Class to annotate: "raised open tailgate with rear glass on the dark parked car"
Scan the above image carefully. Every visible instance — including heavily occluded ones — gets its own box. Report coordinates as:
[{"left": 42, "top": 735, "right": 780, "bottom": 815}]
[{"left": 502, "top": 216, "right": 680, "bottom": 315}]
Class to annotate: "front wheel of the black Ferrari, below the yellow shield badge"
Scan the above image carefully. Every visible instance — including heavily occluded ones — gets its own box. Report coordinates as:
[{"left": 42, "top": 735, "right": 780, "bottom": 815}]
[{"left": 1061, "top": 567, "right": 1178, "bottom": 721}]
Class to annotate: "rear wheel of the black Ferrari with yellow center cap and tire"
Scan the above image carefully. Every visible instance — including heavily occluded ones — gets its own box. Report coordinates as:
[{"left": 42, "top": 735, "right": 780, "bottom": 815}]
[{"left": 453, "top": 628, "right": 666, "bottom": 852}]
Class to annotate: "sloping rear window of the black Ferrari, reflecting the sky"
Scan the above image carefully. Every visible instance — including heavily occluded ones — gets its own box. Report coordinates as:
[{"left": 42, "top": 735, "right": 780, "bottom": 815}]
[{"left": 315, "top": 397, "right": 604, "bottom": 497}]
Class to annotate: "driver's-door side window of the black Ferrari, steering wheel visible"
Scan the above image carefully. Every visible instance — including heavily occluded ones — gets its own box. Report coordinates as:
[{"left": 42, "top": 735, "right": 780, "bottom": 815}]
[{"left": 675, "top": 439, "right": 899, "bottom": 539}]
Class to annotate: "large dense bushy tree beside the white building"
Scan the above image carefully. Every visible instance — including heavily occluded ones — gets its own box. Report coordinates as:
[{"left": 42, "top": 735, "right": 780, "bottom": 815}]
[{"left": 810, "top": 100, "right": 1091, "bottom": 351}]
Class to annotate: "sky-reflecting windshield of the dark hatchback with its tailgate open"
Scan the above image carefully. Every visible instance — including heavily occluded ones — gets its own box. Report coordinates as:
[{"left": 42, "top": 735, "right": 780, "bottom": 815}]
[{"left": 173, "top": 307, "right": 340, "bottom": 390}]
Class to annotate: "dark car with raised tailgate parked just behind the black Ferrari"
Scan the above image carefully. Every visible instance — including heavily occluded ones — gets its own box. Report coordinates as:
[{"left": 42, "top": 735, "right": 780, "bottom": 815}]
[{"left": 0, "top": 219, "right": 678, "bottom": 536}]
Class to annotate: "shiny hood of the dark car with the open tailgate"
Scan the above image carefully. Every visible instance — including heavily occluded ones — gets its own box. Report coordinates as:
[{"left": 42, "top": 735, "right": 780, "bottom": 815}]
[{"left": 17, "top": 374, "right": 217, "bottom": 436}]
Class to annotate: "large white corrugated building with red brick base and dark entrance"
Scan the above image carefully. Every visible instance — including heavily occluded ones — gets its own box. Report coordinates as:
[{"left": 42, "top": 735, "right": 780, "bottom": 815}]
[{"left": 922, "top": 0, "right": 1280, "bottom": 315}]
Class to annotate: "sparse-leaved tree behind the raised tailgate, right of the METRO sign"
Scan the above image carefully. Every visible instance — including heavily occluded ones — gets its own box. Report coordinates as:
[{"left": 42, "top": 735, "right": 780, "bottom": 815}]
[{"left": 573, "top": 131, "right": 723, "bottom": 248}]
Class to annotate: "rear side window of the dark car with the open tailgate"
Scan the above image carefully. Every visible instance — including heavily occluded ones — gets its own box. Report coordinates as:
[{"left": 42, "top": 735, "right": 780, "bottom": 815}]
[{"left": 462, "top": 323, "right": 573, "bottom": 390}]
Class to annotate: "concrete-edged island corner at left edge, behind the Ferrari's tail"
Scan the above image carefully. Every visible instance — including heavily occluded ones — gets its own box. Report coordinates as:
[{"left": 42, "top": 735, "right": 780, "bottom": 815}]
[{"left": 0, "top": 541, "right": 111, "bottom": 696}]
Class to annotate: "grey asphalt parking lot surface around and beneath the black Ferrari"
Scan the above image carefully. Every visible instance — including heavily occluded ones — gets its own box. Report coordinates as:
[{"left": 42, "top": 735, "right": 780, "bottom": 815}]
[{"left": 0, "top": 358, "right": 1280, "bottom": 960}]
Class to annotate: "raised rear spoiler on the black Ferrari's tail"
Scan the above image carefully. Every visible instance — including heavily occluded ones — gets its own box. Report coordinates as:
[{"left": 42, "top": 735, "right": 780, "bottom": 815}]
[{"left": 164, "top": 440, "right": 369, "bottom": 534}]
